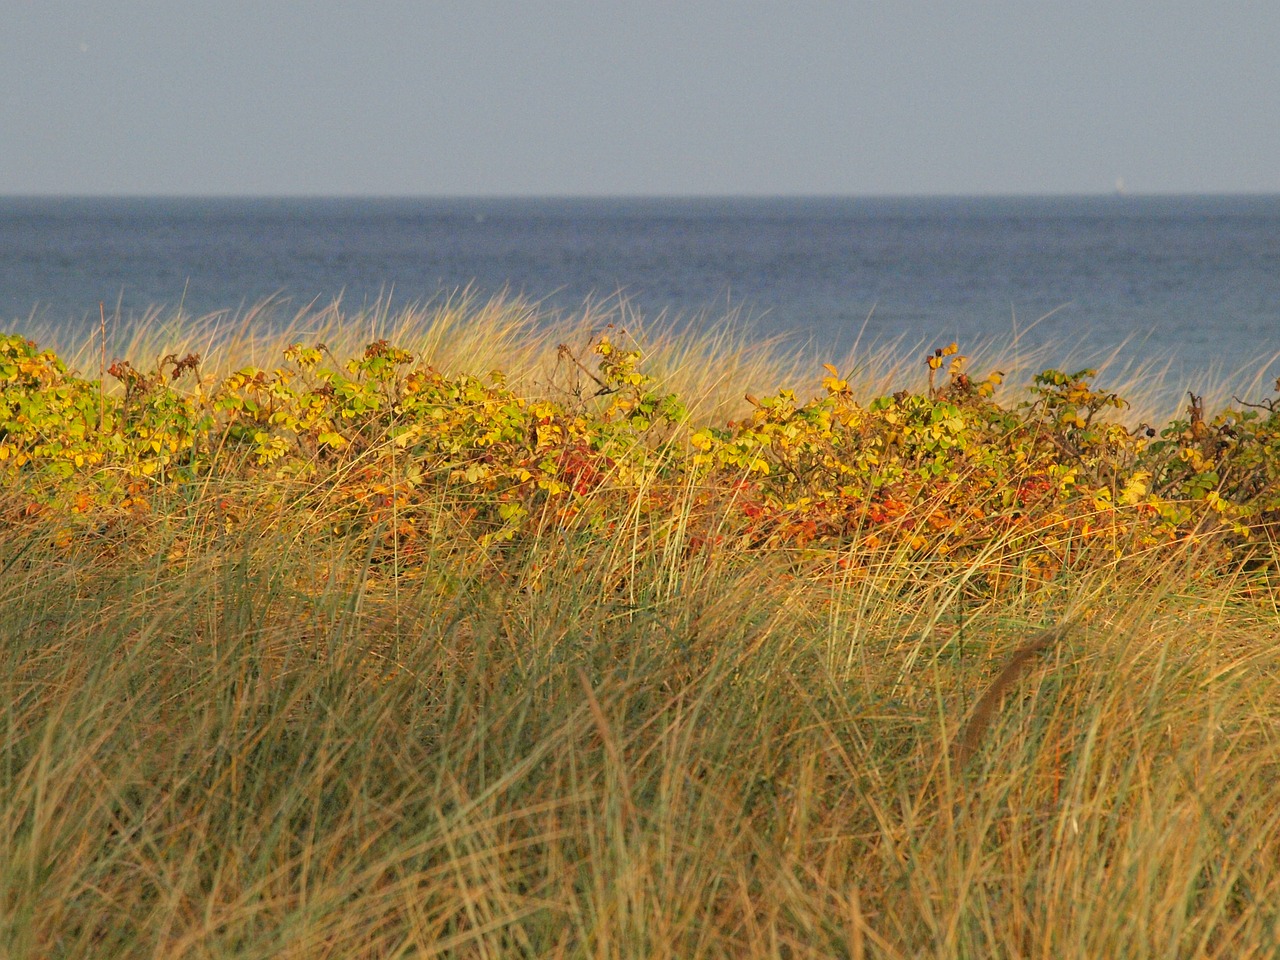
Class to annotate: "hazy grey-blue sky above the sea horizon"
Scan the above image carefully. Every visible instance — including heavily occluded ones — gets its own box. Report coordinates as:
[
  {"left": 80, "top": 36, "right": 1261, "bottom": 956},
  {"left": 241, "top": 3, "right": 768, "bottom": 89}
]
[{"left": 0, "top": 0, "right": 1280, "bottom": 195}]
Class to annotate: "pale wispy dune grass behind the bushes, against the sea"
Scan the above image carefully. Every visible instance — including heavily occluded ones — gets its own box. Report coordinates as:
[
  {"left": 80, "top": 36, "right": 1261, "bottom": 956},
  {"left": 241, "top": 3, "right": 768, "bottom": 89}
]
[{"left": 35, "top": 289, "right": 1244, "bottom": 422}]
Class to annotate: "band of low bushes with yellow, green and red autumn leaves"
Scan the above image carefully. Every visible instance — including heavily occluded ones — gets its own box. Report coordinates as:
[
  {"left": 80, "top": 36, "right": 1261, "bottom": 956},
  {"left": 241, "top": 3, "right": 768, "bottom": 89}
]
[{"left": 0, "top": 316, "right": 1280, "bottom": 589}]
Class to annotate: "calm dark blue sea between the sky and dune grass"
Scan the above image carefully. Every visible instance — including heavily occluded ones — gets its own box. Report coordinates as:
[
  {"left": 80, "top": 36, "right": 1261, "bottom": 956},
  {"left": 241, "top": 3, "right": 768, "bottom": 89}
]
[{"left": 0, "top": 195, "right": 1280, "bottom": 380}]
